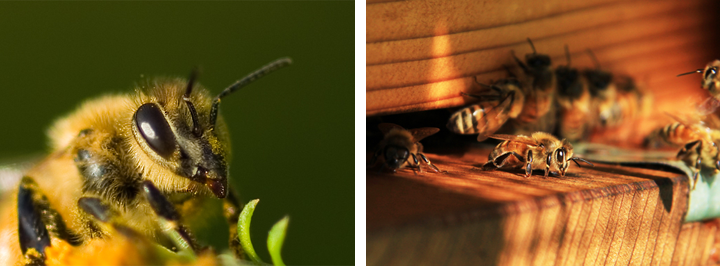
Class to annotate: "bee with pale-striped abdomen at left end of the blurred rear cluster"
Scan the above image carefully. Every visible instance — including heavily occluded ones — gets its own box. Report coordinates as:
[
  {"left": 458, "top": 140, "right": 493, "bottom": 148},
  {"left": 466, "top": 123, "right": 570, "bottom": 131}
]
[{"left": 447, "top": 78, "right": 525, "bottom": 141}]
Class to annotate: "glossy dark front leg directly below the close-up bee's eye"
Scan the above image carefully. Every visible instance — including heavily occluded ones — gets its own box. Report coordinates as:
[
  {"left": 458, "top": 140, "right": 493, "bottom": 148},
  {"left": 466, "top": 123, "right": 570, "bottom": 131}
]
[{"left": 142, "top": 180, "right": 200, "bottom": 252}]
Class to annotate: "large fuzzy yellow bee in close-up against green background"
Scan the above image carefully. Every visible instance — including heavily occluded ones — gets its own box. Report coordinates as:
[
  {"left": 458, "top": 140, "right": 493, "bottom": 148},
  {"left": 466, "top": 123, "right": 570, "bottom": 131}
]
[{"left": 0, "top": 58, "right": 292, "bottom": 265}]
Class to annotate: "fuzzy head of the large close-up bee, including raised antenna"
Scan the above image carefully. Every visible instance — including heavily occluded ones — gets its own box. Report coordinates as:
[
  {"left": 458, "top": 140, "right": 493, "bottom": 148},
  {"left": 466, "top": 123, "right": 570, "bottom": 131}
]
[{"left": 132, "top": 58, "right": 291, "bottom": 198}]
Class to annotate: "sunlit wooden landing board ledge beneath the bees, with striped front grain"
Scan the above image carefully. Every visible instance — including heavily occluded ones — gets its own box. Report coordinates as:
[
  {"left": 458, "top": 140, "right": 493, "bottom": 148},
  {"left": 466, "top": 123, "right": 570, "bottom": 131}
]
[{"left": 367, "top": 150, "right": 718, "bottom": 265}]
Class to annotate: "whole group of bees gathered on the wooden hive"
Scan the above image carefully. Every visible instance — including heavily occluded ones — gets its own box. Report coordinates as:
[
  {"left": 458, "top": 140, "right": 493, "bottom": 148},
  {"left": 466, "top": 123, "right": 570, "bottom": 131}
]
[{"left": 370, "top": 39, "right": 720, "bottom": 186}]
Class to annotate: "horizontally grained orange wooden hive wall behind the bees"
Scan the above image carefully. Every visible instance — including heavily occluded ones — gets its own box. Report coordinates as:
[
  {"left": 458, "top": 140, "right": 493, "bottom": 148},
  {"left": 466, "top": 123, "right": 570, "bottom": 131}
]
[{"left": 366, "top": 0, "right": 718, "bottom": 115}]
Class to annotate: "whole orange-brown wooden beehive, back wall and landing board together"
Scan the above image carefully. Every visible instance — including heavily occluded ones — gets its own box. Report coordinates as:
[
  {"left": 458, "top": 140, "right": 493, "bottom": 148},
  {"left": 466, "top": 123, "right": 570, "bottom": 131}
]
[{"left": 366, "top": 0, "right": 720, "bottom": 265}]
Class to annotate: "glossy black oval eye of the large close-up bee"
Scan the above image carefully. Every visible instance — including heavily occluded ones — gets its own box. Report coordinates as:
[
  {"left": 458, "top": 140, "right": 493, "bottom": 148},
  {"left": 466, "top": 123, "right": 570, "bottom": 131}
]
[{"left": 135, "top": 103, "right": 175, "bottom": 158}]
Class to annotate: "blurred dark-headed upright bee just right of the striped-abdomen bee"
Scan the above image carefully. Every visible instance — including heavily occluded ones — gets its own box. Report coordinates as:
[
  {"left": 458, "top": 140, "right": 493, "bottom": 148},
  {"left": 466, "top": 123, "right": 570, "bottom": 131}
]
[{"left": 513, "top": 38, "right": 557, "bottom": 133}]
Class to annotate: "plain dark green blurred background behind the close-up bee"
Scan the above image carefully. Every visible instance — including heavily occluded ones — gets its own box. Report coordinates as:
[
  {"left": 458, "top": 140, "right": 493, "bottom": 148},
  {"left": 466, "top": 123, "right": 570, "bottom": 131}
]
[{"left": 0, "top": 1, "right": 355, "bottom": 264}]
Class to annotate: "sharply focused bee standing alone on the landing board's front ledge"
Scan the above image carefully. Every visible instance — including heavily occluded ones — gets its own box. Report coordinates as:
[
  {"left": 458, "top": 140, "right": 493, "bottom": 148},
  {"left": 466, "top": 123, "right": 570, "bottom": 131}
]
[{"left": 483, "top": 132, "right": 593, "bottom": 178}]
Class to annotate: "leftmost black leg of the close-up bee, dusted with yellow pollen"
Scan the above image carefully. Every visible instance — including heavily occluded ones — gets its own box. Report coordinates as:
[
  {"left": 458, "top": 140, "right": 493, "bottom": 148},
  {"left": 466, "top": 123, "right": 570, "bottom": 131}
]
[{"left": 17, "top": 177, "right": 82, "bottom": 265}]
